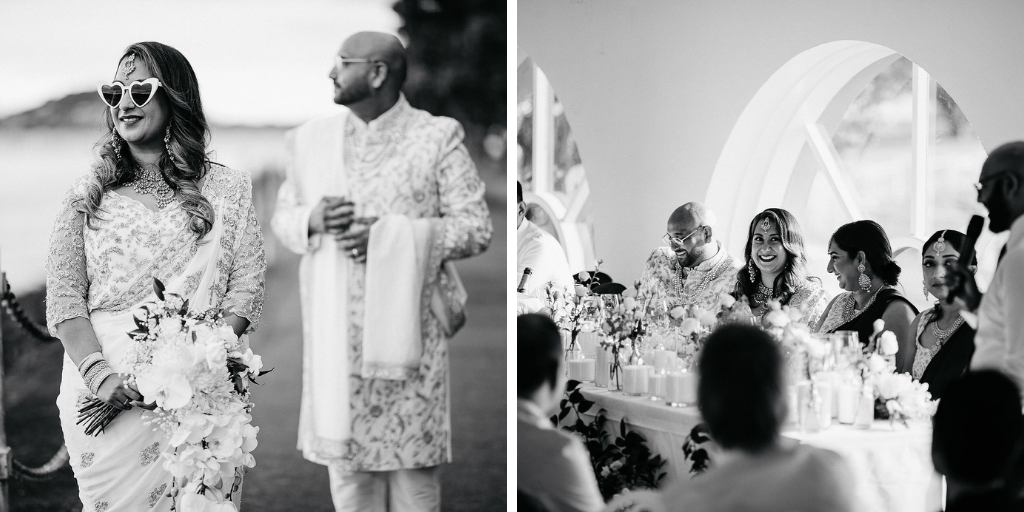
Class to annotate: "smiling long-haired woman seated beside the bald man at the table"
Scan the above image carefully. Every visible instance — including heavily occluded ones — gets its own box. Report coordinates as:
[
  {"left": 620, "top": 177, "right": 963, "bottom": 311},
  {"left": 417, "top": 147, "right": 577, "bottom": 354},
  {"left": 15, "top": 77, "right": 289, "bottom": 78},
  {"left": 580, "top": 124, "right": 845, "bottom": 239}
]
[{"left": 735, "top": 208, "right": 828, "bottom": 326}]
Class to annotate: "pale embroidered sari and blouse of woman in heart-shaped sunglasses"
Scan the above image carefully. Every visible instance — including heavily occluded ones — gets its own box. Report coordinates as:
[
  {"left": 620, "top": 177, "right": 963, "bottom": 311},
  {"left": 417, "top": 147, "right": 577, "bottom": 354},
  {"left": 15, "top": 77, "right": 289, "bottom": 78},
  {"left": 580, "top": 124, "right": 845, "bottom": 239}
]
[{"left": 46, "top": 164, "right": 266, "bottom": 512}]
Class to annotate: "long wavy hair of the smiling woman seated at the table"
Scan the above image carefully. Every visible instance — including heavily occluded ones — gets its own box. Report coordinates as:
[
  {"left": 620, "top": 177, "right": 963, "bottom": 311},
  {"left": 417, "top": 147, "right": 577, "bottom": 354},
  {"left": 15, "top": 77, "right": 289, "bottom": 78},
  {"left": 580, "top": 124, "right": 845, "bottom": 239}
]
[{"left": 735, "top": 208, "right": 813, "bottom": 307}]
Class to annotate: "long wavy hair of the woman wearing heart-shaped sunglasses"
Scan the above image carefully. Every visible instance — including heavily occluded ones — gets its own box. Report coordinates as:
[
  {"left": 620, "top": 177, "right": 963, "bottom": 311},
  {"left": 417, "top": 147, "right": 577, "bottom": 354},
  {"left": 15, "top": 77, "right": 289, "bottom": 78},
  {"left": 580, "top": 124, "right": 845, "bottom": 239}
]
[{"left": 76, "top": 41, "right": 214, "bottom": 239}]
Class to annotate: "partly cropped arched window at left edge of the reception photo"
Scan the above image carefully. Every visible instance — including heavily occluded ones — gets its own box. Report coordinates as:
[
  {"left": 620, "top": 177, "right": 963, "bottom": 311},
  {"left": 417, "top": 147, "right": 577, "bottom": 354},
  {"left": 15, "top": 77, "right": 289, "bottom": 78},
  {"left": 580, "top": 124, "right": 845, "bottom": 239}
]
[{"left": 516, "top": 50, "right": 596, "bottom": 271}]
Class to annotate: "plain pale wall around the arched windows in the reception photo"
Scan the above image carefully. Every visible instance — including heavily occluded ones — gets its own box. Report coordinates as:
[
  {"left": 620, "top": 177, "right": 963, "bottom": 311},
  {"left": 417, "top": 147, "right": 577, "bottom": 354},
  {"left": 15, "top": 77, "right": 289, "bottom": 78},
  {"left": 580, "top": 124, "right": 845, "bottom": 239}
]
[{"left": 517, "top": 0, "right": 1024, "bottom": 283}]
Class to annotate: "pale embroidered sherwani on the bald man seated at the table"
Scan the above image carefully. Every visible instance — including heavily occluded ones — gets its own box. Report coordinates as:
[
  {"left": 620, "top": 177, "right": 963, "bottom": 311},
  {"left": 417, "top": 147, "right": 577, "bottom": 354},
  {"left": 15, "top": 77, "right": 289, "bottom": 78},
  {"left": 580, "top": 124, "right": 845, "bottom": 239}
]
[{"left": 638, "top": 244, "right": 739, "bottom": 311}]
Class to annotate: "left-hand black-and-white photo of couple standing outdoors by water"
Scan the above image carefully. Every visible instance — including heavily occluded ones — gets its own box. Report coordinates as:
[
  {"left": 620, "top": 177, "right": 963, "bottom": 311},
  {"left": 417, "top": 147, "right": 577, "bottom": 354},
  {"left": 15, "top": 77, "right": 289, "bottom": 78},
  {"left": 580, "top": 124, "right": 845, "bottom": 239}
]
[{"left": 0, "top": 0, "right": 505, "bottom": 512}]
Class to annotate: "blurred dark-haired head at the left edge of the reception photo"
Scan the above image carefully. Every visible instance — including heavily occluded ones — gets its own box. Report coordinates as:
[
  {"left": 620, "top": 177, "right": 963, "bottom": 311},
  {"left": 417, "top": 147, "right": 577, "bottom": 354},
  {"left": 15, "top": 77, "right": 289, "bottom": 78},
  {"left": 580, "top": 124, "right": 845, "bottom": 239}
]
[{"left": 516, "top": 313, "right": 562, "bottom": 399}]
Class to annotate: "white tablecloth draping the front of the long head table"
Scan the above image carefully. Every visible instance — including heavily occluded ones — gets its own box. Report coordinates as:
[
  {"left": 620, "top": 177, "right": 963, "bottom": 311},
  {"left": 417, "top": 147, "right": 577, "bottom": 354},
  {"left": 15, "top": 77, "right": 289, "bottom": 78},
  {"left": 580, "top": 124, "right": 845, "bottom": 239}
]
[{"left": 569, "top": 384, "right": 942, "bottom": 512}]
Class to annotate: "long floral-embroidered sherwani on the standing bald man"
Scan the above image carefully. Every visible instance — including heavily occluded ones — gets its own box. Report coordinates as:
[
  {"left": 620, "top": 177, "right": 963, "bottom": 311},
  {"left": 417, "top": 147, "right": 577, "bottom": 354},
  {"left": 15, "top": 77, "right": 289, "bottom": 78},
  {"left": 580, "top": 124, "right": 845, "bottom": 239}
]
[{"left": 272, "top": 96, "right": 492, "bottom": 471}]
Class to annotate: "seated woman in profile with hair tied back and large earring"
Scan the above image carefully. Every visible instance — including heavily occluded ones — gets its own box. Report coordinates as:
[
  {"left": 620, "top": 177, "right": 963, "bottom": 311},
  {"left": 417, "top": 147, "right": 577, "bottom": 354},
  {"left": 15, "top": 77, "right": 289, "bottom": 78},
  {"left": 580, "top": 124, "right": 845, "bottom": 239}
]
[{"left": 815, "top": 220, "right": 918, "bottom": 372}]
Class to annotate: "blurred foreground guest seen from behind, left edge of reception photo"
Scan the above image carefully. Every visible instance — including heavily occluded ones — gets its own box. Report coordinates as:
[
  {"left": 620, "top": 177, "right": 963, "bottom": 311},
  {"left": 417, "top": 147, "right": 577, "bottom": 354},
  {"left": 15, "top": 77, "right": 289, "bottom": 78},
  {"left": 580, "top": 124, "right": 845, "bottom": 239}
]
[{"left": 516, "top": 314, "right": 604, "bottom": 512}]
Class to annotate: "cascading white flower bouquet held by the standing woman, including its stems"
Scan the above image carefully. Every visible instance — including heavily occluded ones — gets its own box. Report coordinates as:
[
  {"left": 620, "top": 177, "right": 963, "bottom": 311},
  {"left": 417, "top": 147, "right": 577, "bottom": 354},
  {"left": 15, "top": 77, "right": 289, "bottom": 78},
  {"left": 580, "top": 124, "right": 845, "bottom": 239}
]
[{"left": 80, "top": 280, "right": 269, "bottom": 511}]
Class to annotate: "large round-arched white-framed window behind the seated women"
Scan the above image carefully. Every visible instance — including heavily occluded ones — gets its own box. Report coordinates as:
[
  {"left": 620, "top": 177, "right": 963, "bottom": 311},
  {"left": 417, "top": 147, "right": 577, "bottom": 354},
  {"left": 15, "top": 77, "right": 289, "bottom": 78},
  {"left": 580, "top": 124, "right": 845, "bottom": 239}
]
[{"left": 708, "top": 41, "right": 1005, "bottom": 307}]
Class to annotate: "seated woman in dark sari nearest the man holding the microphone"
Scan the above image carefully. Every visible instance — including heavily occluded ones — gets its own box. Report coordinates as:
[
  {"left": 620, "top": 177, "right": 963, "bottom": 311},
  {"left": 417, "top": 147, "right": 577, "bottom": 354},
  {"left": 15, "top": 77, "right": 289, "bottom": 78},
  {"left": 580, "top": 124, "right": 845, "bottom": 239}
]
[{"left": 910, "top": 229, "right": 978, "bottom": 399}]
